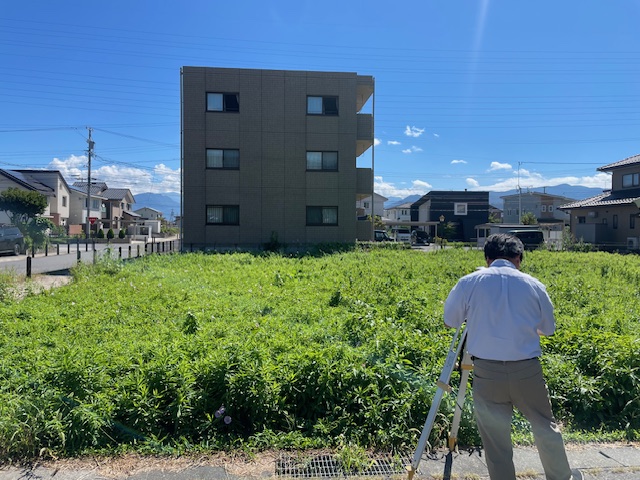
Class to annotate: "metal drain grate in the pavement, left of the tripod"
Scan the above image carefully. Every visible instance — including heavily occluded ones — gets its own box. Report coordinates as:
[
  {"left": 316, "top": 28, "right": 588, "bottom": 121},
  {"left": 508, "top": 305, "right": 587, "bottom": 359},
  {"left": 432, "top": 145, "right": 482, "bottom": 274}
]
[{"left": 276, "top": 454, "right": 411, "bottom": 478}]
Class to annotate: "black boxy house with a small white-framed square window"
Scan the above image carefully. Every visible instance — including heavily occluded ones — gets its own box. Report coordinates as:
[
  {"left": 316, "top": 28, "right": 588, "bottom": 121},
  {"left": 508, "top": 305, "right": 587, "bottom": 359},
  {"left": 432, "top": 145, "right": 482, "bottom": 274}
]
[{"left": 411, "top": 190, "right": 492, "bottom": 242}]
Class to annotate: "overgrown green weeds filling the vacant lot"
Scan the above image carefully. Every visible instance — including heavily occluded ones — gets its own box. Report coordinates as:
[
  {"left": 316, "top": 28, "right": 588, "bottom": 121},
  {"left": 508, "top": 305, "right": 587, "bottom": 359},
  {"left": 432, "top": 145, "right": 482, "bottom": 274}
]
[{"left": 0, "top": 248, "right": 640, "bottom": 460}]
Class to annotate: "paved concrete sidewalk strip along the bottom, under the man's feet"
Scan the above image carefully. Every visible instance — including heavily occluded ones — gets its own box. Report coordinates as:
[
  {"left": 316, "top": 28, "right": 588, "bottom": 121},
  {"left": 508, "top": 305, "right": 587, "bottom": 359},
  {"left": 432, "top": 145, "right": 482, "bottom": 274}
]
[{"left": 0, "top": 444, "right": 640, "bottom": 480}]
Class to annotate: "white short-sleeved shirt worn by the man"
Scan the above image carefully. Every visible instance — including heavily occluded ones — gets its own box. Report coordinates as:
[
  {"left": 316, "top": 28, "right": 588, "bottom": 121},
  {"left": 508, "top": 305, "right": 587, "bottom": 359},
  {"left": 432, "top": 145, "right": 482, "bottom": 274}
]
[{"left": 444, "top": 259, "right": 555, "bottom": 361}]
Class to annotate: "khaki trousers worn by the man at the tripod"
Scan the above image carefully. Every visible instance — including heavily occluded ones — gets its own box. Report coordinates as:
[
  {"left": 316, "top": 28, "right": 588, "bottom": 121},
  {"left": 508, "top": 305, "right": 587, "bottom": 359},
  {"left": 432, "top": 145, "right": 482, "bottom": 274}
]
[{"left": 473, "top": 358, "right": 571, "bottom": 480}]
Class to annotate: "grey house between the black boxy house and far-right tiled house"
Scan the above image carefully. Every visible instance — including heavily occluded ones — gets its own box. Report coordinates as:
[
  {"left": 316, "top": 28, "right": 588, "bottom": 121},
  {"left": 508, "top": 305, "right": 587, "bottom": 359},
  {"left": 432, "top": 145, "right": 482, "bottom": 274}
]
[{"left": 500, "top": 191, "right": 575, "bottom": 225}]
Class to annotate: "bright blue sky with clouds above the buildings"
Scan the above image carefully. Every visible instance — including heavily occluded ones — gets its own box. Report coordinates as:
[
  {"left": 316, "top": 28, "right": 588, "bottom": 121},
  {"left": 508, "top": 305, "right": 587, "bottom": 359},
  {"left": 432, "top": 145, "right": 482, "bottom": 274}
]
[{"left": 0, "top": 0, "right": 640, "bottom": 197}]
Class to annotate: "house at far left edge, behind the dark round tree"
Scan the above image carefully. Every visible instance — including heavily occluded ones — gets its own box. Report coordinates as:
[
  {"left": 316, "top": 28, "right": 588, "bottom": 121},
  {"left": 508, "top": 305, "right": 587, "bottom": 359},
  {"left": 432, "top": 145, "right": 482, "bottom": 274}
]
[{"left": 0, "top": 170, "right": 70, "bottom": 226}]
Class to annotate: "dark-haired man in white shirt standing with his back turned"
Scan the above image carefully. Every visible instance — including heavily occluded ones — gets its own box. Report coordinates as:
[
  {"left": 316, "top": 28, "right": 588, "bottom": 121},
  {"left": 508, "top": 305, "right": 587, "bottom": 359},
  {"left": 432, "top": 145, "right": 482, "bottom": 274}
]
[{"left": 444, "top": 234, "right": 583, "bottom": 480}]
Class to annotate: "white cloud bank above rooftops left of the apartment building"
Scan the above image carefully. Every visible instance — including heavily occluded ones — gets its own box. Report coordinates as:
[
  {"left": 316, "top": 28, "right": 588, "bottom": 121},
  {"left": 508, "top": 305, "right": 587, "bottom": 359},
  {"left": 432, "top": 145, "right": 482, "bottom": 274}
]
[{"left": 49, "top": 155, "right": 180, "bottom": 195}]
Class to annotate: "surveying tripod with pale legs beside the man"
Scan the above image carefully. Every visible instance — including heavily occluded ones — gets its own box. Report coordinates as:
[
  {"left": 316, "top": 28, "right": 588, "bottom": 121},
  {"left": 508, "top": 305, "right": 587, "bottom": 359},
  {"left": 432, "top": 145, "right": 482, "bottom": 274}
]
[{"left": 407, "top": 327, "right": 473, "bottom": 480}]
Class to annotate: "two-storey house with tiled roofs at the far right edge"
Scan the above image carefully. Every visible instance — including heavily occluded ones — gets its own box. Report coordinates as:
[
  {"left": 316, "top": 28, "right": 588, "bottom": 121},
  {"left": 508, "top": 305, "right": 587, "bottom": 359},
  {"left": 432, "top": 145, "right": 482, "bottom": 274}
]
[{"left": 559, "top": 155, "right": 640, "bottom": 250}]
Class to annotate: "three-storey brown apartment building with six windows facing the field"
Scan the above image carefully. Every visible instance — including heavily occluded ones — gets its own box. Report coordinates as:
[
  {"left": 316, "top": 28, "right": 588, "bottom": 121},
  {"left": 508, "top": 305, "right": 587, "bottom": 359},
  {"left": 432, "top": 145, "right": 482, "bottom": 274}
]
[{"left": 181, "top": 67, "right": 374, "bottom": 250}]
